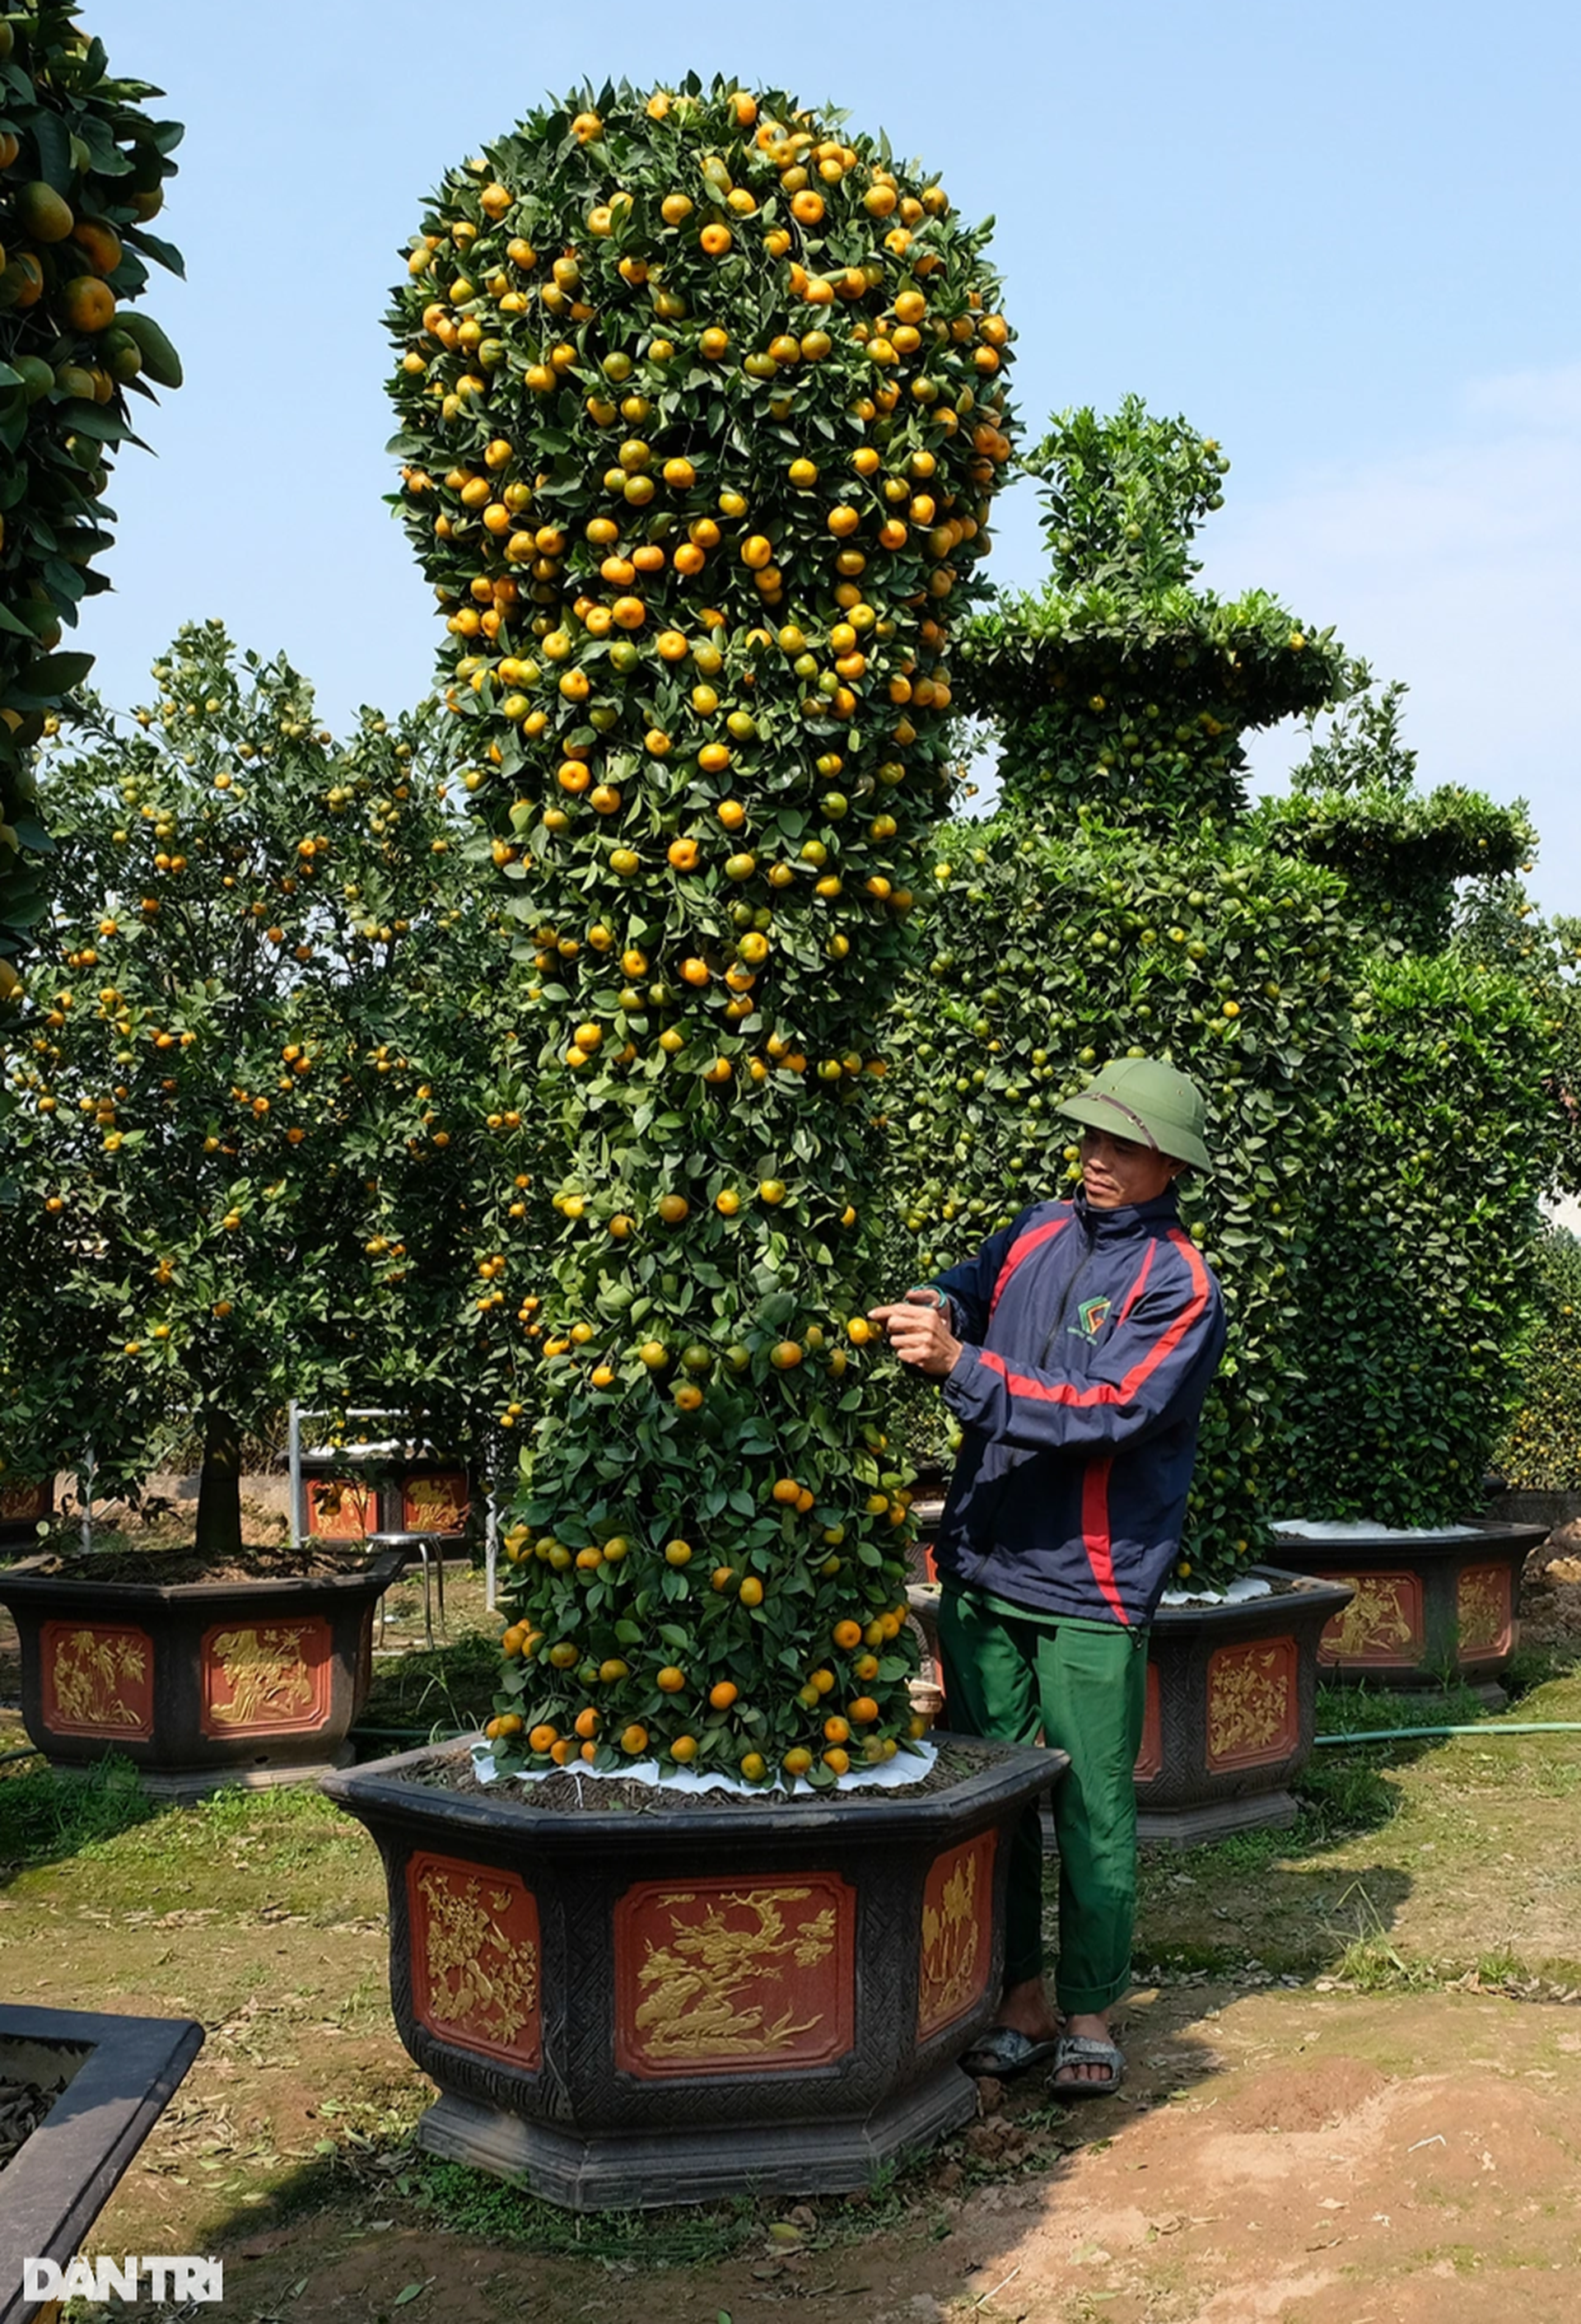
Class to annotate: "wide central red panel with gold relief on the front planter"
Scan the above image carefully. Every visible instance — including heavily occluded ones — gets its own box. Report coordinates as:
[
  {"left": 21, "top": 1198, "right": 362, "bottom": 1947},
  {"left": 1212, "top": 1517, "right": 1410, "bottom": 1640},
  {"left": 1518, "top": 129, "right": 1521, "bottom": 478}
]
[{"left": 613, "top": 1874, "right": 856, "bottom": 2080}]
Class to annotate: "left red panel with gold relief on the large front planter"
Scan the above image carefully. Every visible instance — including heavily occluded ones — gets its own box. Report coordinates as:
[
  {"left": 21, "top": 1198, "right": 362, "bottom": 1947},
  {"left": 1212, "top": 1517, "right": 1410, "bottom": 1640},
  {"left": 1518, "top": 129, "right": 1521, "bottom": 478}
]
[{"left": 407, "top": 1855, "right": 544, "bottom": 2073}]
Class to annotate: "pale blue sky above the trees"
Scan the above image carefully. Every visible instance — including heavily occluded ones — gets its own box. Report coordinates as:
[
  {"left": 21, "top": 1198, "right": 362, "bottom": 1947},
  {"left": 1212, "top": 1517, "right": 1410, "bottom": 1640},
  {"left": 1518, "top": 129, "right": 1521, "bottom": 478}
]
[{"left": 84, "top": 0, "right": 1581, "bottom": 911}]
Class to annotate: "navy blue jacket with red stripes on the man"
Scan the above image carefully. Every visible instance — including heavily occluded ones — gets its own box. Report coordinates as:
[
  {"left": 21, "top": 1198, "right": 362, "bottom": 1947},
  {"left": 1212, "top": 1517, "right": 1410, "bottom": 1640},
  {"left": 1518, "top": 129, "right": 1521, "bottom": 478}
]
[{"left": 935, "top": 1188, "right": 1225, "bottom": 1625}]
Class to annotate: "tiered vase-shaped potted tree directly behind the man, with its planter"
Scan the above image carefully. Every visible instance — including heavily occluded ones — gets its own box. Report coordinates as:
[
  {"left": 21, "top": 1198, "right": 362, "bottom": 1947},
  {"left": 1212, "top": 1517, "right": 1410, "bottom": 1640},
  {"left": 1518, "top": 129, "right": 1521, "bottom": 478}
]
[{"left": 888, "top": 398, "right": 1353, "bottom": 1841}]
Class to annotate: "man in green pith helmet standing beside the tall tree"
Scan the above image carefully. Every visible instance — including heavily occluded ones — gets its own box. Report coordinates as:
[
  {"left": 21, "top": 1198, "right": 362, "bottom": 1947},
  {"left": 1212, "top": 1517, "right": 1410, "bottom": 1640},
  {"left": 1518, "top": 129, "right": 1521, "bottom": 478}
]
[{"left": 874, "top": 1057, "right": 1225, "bottom": 2098}]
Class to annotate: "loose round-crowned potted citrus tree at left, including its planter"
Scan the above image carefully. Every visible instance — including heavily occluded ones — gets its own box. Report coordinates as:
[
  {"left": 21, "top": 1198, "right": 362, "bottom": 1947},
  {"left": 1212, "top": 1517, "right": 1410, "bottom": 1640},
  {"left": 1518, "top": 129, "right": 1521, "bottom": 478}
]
[{"left": 0, "top": 625, "right": 502, "bottom": 1792}]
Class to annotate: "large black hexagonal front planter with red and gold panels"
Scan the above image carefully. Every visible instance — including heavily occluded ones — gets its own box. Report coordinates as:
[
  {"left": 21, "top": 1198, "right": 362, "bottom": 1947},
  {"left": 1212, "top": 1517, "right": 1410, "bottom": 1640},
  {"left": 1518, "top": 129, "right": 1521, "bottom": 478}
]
[{"left": 323, "top": 1736, "right": 1065, "bottom": 2210}]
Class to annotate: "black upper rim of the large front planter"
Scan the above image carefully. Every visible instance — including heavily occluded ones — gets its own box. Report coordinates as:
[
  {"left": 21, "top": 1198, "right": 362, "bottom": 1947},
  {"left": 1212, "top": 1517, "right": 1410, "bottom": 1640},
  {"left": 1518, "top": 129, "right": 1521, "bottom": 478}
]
[{"left": 320, "top": 1729, "right": 1067, "bottom": 1850}]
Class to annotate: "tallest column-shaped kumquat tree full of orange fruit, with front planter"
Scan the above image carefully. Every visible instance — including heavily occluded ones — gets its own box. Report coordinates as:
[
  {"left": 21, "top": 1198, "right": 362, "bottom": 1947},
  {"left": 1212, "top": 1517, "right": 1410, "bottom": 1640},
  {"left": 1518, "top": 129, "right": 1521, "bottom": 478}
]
[{"left": 328, "top": 82, "right": 1053, "bottom": 2205}]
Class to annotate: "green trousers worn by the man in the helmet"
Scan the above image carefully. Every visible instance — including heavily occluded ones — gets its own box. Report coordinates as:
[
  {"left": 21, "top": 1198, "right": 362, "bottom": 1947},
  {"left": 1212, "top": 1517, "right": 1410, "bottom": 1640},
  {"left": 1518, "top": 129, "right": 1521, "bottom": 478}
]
[{"left": 940, "top": 1583, "right": 1146, "bottom": 2015}]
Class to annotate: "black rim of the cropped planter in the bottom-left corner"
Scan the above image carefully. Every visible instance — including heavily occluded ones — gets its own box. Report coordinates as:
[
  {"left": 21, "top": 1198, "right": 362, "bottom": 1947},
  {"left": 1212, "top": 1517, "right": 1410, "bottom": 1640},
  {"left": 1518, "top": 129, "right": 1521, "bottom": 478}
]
[{"left": 0, "top": 2004, "right": 203, "bottom": 2324}]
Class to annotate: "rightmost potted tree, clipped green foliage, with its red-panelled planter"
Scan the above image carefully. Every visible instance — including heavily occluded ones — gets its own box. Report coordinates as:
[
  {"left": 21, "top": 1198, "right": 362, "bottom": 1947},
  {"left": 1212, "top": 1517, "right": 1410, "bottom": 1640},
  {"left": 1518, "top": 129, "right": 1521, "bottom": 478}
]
[{"left": 1262, "top": 667, "right": 1576, "bottom": 1704}]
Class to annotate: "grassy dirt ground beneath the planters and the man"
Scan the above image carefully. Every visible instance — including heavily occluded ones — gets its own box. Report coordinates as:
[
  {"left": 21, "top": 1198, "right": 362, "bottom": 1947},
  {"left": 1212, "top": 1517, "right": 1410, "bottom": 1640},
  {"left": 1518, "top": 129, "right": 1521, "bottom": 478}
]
[{"left": 0, "top": 1546, "right": 1581, "bottom": 2324}]
